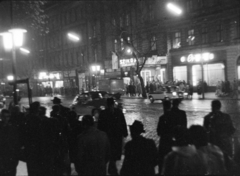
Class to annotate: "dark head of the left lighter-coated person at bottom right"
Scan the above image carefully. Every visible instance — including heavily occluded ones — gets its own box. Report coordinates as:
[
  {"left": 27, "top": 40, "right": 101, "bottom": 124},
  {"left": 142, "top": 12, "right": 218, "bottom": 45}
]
[{"left": 173, "top": 126, "right": 189, "bottom": 146}]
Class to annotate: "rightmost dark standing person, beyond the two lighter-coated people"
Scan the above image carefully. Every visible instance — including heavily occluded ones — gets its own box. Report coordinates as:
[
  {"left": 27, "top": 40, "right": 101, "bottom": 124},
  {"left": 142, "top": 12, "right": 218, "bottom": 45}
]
[{"left": 204, "top": 100, "right": 235, "bottom": 157}]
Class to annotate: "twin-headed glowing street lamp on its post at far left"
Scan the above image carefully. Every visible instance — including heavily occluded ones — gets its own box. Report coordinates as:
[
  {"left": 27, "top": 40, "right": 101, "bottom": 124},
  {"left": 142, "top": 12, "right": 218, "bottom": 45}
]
[{"left": 1, "top": 28, "right": 27, "bottom": 105}]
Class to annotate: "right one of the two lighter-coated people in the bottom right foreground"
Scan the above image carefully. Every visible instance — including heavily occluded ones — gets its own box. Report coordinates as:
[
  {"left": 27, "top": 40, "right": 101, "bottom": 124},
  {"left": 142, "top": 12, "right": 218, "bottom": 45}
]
[{"left": 189, "top": 125, "right": 227, "bottom": 175}]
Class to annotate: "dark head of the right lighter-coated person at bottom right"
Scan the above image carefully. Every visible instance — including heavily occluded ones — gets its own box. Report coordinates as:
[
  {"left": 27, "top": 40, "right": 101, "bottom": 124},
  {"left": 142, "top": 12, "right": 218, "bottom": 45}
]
[{"left": 189, "top": 125, "right": 208, "bottom": 148}]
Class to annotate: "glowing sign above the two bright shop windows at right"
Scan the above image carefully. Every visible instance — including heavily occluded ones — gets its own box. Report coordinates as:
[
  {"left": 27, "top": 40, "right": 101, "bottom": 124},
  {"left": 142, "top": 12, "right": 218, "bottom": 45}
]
[{"left": 180, "top": 53, "right": 215, "bottom": 63}]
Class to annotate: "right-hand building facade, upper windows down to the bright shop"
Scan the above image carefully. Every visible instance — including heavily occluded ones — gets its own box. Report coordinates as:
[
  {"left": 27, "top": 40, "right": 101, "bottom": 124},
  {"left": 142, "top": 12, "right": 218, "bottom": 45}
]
[{"left": 166, "top": 0, "right": 240, "bottom": 90}]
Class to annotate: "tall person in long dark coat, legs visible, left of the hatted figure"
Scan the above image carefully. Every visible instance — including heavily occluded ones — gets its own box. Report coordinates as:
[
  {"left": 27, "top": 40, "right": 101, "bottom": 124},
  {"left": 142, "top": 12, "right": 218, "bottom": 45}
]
[{"left": 98, "top": 98, "right": 128, "bottom": 175}]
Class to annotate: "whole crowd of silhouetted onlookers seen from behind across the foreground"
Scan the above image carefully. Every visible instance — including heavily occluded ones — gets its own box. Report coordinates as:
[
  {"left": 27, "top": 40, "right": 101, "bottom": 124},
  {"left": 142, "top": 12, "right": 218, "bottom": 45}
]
[{"left": 0, "top": 97, "right": 239, "bottom": 176}]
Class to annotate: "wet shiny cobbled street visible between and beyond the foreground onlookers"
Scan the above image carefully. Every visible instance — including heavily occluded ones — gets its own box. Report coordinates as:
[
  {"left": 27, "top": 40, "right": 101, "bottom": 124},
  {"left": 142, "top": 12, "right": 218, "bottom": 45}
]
[{"left": 15, "top": 97, "right": 240, "bottom": 175}]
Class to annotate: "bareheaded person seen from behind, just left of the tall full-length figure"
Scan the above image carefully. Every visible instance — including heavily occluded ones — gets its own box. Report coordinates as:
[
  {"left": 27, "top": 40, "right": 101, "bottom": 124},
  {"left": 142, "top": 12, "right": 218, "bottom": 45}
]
[{"left": 77, "top": 115, "right": 110, "bottom": 176}]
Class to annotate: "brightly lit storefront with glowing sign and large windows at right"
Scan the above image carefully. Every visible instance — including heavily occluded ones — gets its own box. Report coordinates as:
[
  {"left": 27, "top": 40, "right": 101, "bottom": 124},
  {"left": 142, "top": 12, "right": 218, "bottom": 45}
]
[{"left": 172, "top": 51, "right": 226, "bottom": 87}]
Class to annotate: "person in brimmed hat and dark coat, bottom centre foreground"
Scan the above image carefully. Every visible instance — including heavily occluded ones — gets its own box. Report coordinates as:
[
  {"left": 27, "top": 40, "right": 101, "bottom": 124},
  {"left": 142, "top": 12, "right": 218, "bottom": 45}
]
[{"left": 120, "top": 121, "right": 157, "bottom": 176}]
